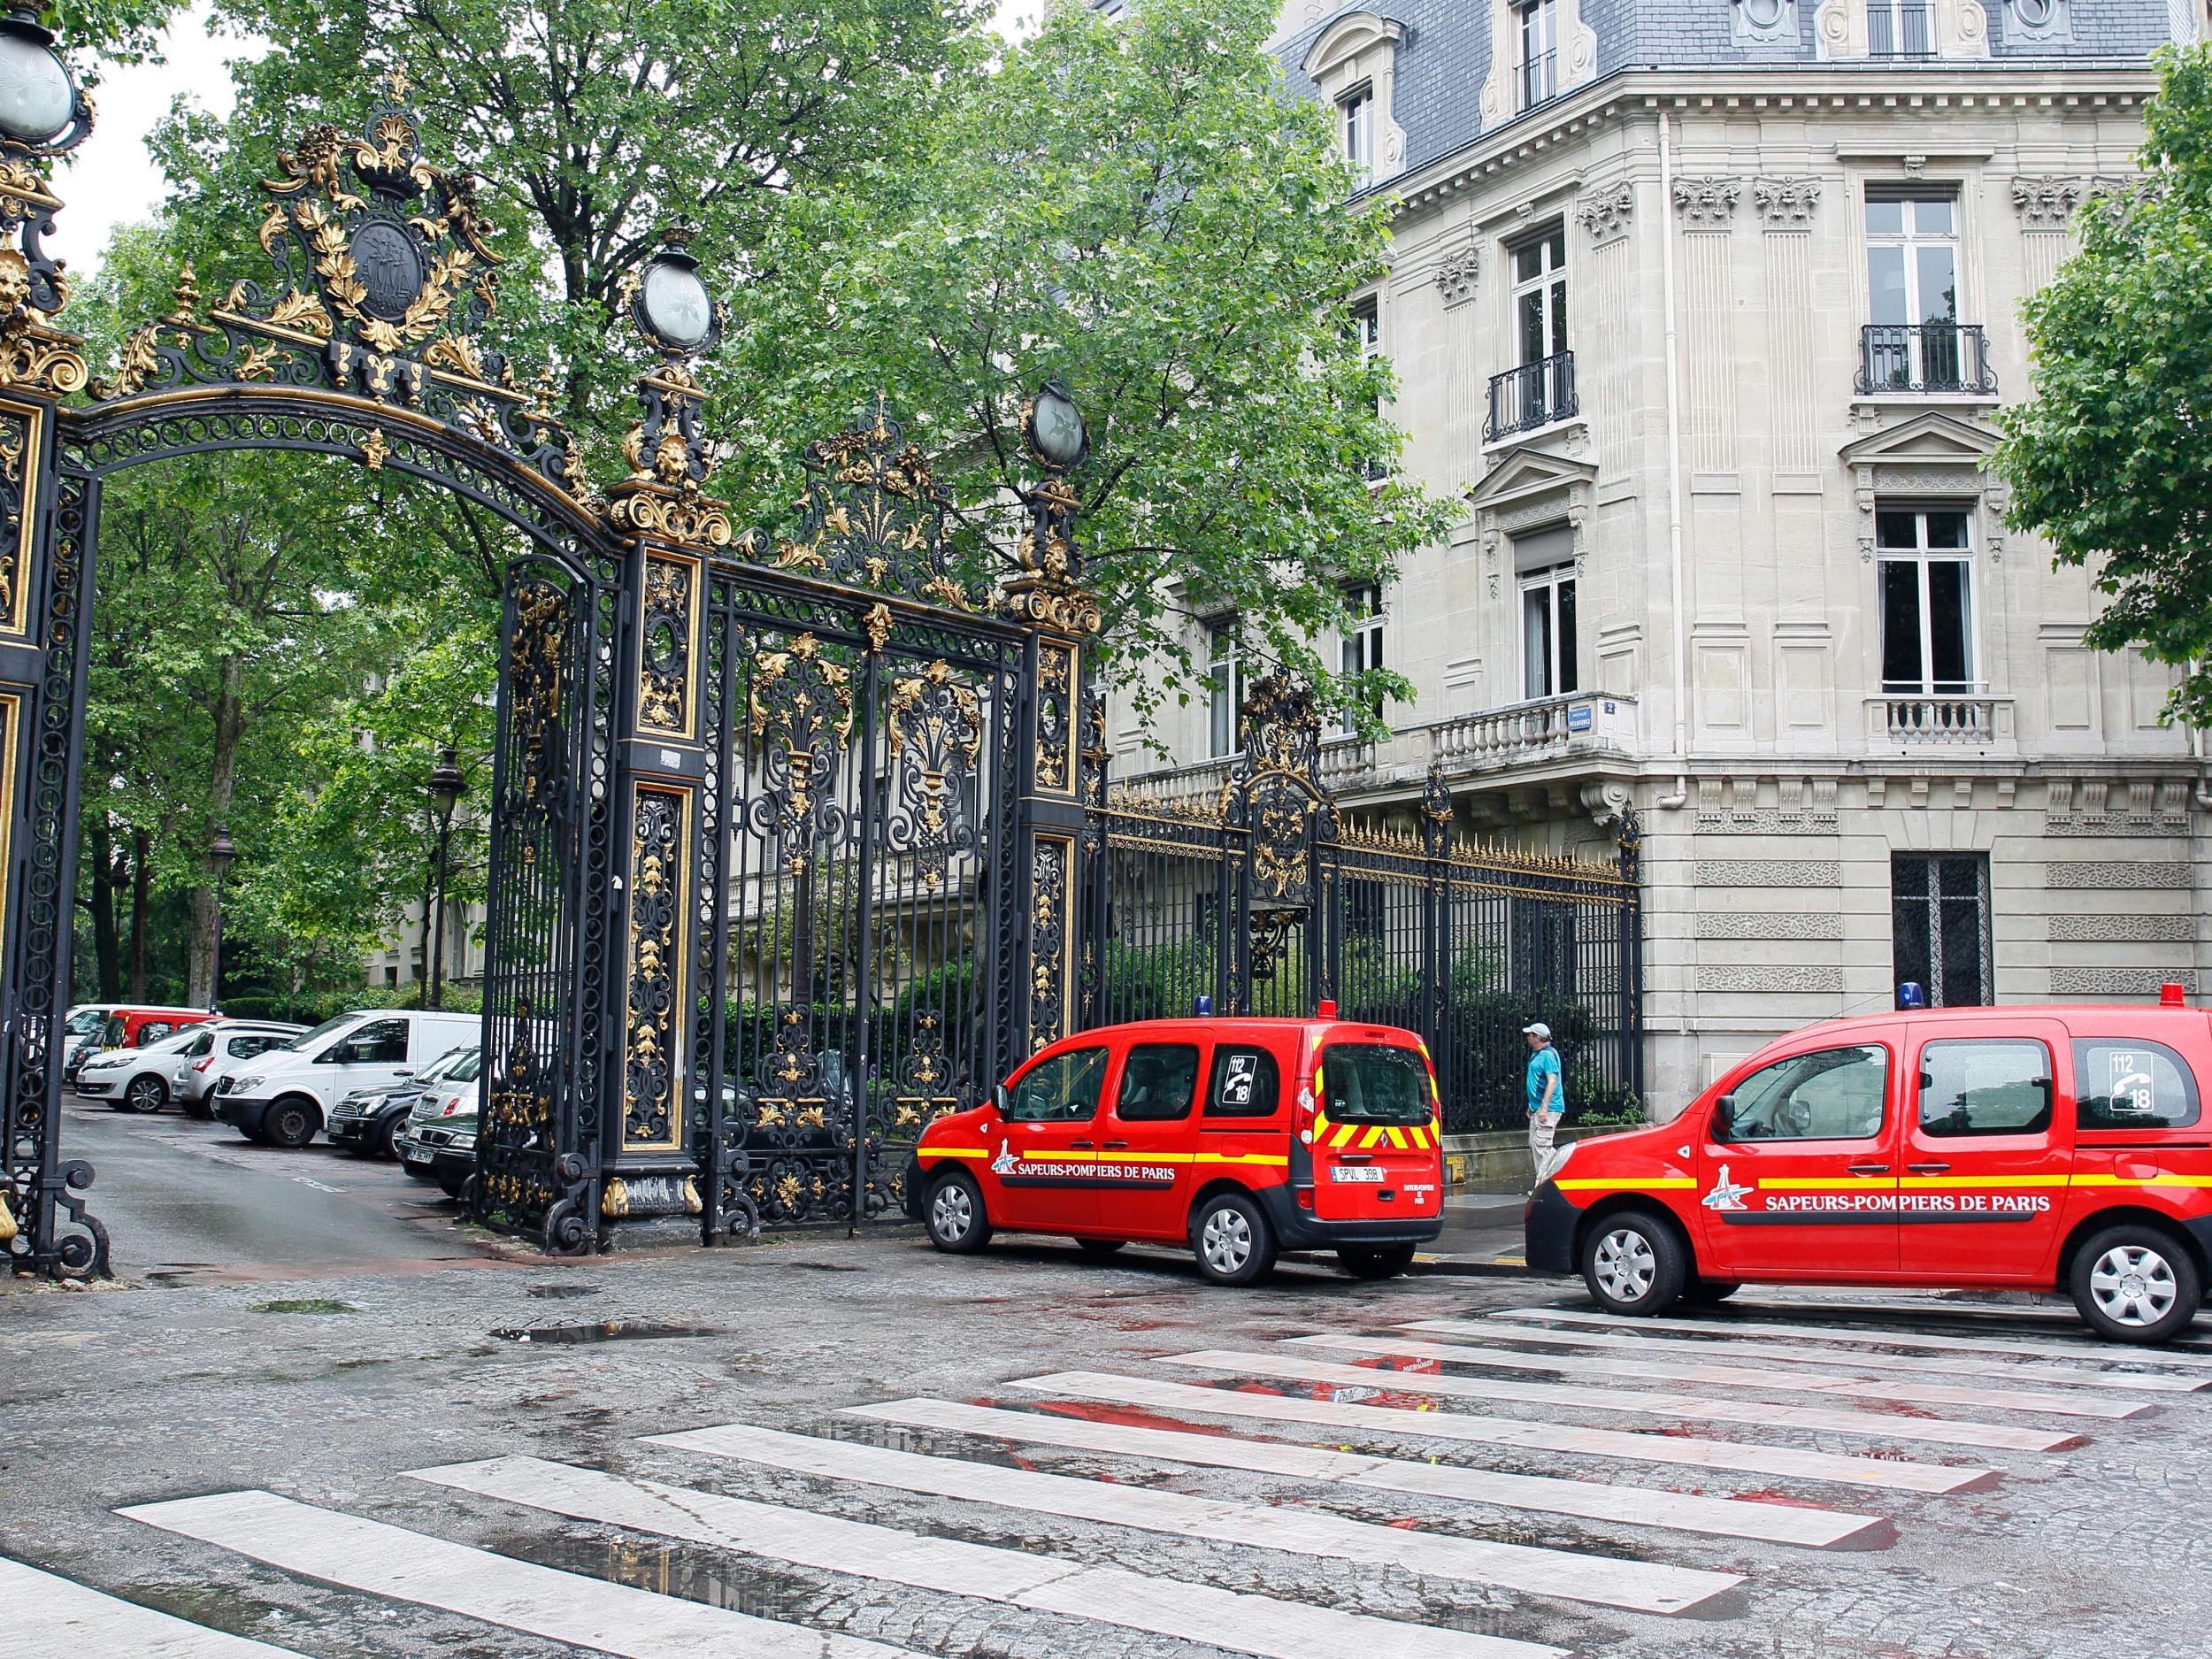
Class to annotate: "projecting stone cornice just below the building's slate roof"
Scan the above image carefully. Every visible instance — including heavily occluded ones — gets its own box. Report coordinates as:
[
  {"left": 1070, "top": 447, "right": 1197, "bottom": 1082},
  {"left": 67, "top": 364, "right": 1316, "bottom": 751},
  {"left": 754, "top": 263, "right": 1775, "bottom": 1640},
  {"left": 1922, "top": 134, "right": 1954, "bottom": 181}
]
[{"left": 1371, "top": 60, "right": 2159, "bottom": 224}]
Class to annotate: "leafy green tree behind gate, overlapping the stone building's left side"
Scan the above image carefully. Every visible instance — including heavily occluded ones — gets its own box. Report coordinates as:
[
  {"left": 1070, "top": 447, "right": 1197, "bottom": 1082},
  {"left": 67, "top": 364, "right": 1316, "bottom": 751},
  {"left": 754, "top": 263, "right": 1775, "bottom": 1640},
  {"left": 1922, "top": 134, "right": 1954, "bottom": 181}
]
[{"left": 717, "top": 0, "right": 1455, "bottom": 730}]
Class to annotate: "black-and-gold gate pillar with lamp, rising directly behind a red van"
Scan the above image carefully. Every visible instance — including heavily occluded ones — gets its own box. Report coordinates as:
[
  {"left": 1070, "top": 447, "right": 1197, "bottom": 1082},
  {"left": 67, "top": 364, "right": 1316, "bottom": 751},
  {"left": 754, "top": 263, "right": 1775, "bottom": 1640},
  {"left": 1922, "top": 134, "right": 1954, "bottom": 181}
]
[{"left": 1000, "top": 380, "right": 1104, "bottom": 1075}]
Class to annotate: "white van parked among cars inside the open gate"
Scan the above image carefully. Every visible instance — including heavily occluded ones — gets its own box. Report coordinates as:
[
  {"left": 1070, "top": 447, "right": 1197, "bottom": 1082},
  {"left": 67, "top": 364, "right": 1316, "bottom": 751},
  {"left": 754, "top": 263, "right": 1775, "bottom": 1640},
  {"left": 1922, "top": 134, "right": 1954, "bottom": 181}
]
[{"left": 215, "top": 1009, "right": 482, "bottom": 1146}]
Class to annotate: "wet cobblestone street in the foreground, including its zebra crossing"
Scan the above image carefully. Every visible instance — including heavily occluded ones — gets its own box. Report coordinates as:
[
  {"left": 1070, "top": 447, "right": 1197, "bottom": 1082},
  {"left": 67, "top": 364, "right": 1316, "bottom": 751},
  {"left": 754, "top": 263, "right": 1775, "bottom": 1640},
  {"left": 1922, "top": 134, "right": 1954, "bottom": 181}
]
[{"left": 0, "top": 1234, "right": 2212, "bottom": 1659}]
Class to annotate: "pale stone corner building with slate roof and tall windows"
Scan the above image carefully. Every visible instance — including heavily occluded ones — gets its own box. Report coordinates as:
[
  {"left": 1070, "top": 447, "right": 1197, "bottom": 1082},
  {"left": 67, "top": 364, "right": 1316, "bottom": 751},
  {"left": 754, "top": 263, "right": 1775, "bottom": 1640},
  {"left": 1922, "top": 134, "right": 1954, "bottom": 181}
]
[{"left": 1109, "top": 0, "right": 2212, "bottom": 1118}]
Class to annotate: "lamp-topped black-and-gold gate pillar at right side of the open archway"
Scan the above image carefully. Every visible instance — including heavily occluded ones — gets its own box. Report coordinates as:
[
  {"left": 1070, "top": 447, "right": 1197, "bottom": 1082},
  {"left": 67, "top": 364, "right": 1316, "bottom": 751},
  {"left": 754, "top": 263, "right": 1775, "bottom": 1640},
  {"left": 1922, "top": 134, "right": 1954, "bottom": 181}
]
[{"left": 582, "top": 250, "right": 734, "bottom": 1237}]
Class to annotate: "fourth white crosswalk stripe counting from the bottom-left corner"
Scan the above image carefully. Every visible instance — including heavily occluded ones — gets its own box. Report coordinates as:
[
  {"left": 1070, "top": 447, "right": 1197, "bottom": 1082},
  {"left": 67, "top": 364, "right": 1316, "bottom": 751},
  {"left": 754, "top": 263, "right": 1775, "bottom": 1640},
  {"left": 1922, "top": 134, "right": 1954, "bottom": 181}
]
[{"left": 650, "top": 1423, "right": 1743, "bottom": 1613}]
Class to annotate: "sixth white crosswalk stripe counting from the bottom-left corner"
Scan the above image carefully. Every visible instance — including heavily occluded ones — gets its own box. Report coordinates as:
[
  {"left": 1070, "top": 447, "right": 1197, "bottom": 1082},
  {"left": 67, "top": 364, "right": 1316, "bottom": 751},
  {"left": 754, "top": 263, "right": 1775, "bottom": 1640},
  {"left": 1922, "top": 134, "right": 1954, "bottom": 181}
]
[{"left": 1007, "top": 1371, "right": 1995, "bottom": 1513}]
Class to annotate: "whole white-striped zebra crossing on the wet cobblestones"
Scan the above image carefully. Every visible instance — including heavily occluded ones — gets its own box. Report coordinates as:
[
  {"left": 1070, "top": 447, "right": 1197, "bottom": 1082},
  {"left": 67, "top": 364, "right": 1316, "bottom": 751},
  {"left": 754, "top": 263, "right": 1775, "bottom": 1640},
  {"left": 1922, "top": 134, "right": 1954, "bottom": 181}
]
[{"left": 21, "top": 1301, "right": 2212, "bottom": 1659}]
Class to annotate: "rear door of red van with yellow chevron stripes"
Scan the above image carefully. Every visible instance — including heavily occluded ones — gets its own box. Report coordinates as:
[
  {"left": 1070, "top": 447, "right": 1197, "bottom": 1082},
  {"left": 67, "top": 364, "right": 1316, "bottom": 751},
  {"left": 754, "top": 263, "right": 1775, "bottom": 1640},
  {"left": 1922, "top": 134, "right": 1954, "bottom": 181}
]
[{"left": 1314, "top": 1031, "right": 1442, "bottom": 1221}]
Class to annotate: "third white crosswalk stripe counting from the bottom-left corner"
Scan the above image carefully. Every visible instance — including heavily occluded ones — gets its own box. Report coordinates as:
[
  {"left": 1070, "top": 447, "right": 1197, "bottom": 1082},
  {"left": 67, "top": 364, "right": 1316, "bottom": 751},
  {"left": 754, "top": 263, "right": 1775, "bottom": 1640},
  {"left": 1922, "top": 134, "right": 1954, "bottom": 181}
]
[{"left": 411, "top": 1451, "right": 1564, "bottom": 1659}]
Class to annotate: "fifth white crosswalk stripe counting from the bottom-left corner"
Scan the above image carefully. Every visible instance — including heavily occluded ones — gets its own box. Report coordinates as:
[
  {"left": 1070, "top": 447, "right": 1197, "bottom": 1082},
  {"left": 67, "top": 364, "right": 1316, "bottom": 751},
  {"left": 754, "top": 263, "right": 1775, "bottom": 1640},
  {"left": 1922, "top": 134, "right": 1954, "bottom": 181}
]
[{"left": 845, "top": 1401, "right": 1883, "bottom": 1547}]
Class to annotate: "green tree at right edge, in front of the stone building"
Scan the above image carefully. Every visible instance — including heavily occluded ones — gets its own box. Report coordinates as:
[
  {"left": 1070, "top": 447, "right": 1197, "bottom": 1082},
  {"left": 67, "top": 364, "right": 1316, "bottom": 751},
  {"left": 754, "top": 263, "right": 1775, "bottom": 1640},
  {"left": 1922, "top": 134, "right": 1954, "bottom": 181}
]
[{"left": 1991, "top": 47, "right": 2212, "bottom": 726}]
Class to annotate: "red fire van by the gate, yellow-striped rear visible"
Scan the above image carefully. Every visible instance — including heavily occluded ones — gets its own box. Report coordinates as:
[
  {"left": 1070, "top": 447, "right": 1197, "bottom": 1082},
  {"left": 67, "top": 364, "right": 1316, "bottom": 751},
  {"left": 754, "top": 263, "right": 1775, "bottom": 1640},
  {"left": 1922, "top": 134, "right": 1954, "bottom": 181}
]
[{"left": 907, "top": 1004, "right": 1445, "bottom": 1286}]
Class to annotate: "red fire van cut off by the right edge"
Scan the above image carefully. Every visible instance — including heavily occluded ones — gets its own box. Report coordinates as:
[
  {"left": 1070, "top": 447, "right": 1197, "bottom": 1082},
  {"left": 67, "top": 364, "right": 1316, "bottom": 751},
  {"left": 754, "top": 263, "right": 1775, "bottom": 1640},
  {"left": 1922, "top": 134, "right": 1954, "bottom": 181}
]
[{"left": 1526, "top": 987, "right": 2212, "bottom": 1343}]
